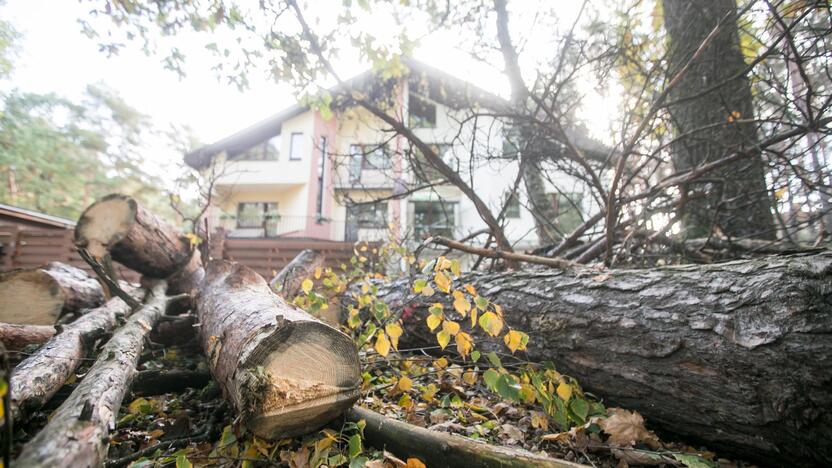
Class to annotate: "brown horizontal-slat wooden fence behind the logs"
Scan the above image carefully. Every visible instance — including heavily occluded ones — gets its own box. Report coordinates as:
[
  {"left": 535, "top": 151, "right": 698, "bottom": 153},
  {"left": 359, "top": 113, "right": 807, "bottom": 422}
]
[{"left": 0, "top": 226, "right": 364, "bottom": 281}]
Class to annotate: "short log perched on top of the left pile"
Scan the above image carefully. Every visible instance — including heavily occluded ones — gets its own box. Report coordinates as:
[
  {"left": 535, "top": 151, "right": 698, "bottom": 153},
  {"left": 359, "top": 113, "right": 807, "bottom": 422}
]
[{"left": 75, "top": 194, "right": 202, "bottom": 294}]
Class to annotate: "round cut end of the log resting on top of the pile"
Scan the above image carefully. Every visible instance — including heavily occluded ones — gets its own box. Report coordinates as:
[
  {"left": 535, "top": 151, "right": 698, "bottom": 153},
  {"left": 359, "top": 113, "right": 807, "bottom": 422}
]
[{"left": 75, "top": 194, "right": 138, "bottom": 258}]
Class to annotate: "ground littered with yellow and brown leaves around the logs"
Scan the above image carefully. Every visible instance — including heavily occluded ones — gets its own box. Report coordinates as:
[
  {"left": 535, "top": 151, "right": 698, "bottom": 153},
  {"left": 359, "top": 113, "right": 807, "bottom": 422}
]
[{"left": 9, "top": 341, "right": 753, "bottom": 468}]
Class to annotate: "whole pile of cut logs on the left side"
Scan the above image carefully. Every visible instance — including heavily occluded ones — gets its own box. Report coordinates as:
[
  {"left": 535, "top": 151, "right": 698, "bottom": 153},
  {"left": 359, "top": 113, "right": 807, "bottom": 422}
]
[{"left": 0, "top": 194, "right": 362, "bottom": 467}]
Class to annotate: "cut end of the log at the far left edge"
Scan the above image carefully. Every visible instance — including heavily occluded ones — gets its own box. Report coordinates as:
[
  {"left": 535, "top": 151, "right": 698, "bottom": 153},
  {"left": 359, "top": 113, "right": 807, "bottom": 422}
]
[{"left": 0, "top": 270, "right": 66, "bottom": 325}]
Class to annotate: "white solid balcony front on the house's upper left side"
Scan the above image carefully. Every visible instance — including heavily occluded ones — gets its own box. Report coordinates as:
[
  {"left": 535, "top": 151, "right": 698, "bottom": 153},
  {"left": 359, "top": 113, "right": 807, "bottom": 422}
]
[{"left": 216, "top": 161, "right": 309, "bottom": 187}]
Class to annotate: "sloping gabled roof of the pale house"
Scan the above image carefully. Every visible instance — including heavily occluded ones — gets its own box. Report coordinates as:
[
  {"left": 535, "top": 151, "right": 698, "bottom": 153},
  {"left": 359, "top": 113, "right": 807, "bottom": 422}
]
[{"left": 185, "top": 57, "right": 610, "bottom": 169}]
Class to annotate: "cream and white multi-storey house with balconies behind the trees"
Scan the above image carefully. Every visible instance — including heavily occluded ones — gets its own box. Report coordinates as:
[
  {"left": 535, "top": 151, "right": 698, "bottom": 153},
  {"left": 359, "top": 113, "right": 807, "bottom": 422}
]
[{"left": 185, "top": 59, "right": 592, "bottom": 248}]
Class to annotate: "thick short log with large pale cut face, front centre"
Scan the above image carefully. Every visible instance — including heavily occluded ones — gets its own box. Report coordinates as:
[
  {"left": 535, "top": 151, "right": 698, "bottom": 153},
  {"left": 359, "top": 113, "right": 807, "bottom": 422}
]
[{"left": 196, "top": 260, "right": 361, "bottom": 438}]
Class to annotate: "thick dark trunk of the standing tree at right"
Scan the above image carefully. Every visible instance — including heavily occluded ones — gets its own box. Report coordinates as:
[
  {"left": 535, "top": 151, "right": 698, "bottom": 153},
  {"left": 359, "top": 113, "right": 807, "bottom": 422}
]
[{"left": 663, "top": 0, "right": 775, "bottom": 239}]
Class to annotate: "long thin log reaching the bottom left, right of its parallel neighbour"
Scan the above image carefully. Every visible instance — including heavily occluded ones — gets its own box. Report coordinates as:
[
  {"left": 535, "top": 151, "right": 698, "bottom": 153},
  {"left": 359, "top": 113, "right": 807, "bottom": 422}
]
[{"left": 15, "top": 281, "right": 167, "bottom": 468}]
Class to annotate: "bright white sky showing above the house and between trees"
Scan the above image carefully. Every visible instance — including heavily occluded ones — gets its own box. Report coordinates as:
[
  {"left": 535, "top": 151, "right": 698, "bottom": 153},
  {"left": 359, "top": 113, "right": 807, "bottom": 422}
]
[{"left": 0, "top": 0, "right": 615, "bottom": 186}]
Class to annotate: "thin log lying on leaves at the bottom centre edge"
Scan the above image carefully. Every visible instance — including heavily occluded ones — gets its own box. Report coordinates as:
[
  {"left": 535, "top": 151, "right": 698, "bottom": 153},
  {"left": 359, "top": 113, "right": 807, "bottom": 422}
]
[{"left": 346, "top": 406, "right": 584, "bottom": 468}]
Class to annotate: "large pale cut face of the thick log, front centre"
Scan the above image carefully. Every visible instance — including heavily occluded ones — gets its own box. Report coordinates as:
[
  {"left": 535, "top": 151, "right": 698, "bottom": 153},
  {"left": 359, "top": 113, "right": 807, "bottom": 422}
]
[{"left": 238, "top": 321, "right": 361, "bottom": 439}]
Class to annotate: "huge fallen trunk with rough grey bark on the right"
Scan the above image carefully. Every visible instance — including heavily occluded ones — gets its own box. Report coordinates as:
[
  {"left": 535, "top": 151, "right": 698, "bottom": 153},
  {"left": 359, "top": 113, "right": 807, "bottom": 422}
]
[{"left": 368, "top": 251, "right": 832, "bottom": 465}]
